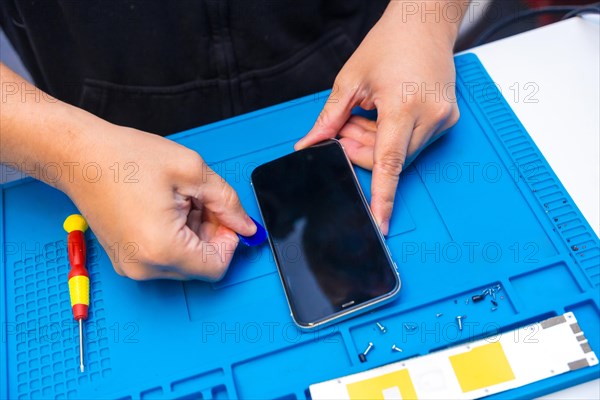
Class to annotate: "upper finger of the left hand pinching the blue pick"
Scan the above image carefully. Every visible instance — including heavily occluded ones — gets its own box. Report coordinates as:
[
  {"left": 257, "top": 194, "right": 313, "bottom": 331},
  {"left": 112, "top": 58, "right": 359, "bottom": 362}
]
[{"left": 194, "top": 167, "right": 256, "bottom": 236}]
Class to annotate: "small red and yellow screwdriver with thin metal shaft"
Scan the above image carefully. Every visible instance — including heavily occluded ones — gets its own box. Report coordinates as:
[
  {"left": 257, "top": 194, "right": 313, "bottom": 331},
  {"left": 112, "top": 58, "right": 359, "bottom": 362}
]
[{"left": 63, "top": 214, "right": 90, "bottom": 372}]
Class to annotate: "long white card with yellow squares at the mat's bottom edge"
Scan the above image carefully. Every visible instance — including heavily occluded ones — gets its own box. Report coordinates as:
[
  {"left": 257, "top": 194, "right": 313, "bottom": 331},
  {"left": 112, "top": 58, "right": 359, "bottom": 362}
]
[{"left": 310, "top": 312, "right": 598, "bottom": 400}]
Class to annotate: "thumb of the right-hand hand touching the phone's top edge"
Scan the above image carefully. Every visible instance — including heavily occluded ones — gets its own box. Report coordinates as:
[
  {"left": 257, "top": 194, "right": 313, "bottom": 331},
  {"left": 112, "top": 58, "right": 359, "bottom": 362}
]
[{"left": 294, "top": 81, "right": 357, "bottom": 150}]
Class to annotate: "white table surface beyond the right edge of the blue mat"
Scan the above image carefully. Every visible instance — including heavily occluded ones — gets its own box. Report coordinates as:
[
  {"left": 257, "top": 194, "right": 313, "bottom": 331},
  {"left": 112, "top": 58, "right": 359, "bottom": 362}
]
[{"left": 468, "top": 15, "right": 600, "bottom": 399}]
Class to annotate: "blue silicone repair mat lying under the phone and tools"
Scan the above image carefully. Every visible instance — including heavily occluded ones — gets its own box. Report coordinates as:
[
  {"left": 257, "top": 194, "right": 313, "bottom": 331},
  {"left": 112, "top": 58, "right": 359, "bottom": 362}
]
[{"left": 0, "top": 55, "right": 600, "bottom": 399}]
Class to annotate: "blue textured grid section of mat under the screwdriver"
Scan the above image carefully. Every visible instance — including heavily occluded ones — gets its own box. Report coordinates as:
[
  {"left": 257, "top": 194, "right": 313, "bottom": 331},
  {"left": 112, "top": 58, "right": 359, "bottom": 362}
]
[{"left": 7, "top": 240, "right": 110, "bottom": 399}]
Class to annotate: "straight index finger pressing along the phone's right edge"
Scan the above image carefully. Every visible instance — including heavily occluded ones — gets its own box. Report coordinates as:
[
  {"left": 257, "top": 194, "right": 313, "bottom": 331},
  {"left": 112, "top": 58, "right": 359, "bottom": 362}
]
[{"left": 371, "top": 109, "right": 414, "bottom": 235}]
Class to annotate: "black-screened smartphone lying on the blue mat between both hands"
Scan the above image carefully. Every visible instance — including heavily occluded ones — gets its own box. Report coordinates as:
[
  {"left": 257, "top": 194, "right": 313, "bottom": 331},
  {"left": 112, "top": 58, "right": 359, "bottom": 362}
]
[{"left": 252, "top": 139, "right": 400, "bottom": 329}]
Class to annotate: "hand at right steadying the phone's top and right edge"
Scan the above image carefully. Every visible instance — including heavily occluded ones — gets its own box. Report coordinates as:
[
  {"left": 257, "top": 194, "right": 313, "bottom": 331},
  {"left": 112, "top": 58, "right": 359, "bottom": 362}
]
[{"left": 295, "top": 1, "right": 459, "bottom": 235}]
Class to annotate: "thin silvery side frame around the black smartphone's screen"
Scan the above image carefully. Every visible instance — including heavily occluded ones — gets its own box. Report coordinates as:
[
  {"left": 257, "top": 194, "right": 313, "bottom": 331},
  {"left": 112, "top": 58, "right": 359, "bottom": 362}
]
[{"left": 250, "top": 138, "right": 402, "bottom": 331}]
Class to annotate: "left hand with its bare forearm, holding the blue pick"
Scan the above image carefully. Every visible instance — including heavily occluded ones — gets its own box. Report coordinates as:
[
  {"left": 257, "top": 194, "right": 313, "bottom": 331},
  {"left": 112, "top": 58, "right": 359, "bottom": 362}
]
[{"left": 0, "top": 63, "right": 256, "bottom": 280}]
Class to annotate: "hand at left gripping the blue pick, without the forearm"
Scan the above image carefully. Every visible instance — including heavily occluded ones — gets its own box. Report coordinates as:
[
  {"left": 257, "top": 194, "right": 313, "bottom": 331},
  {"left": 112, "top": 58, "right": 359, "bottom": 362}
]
[{"left": 59, "top": 121, "right": 256, "bottom": 281}]
